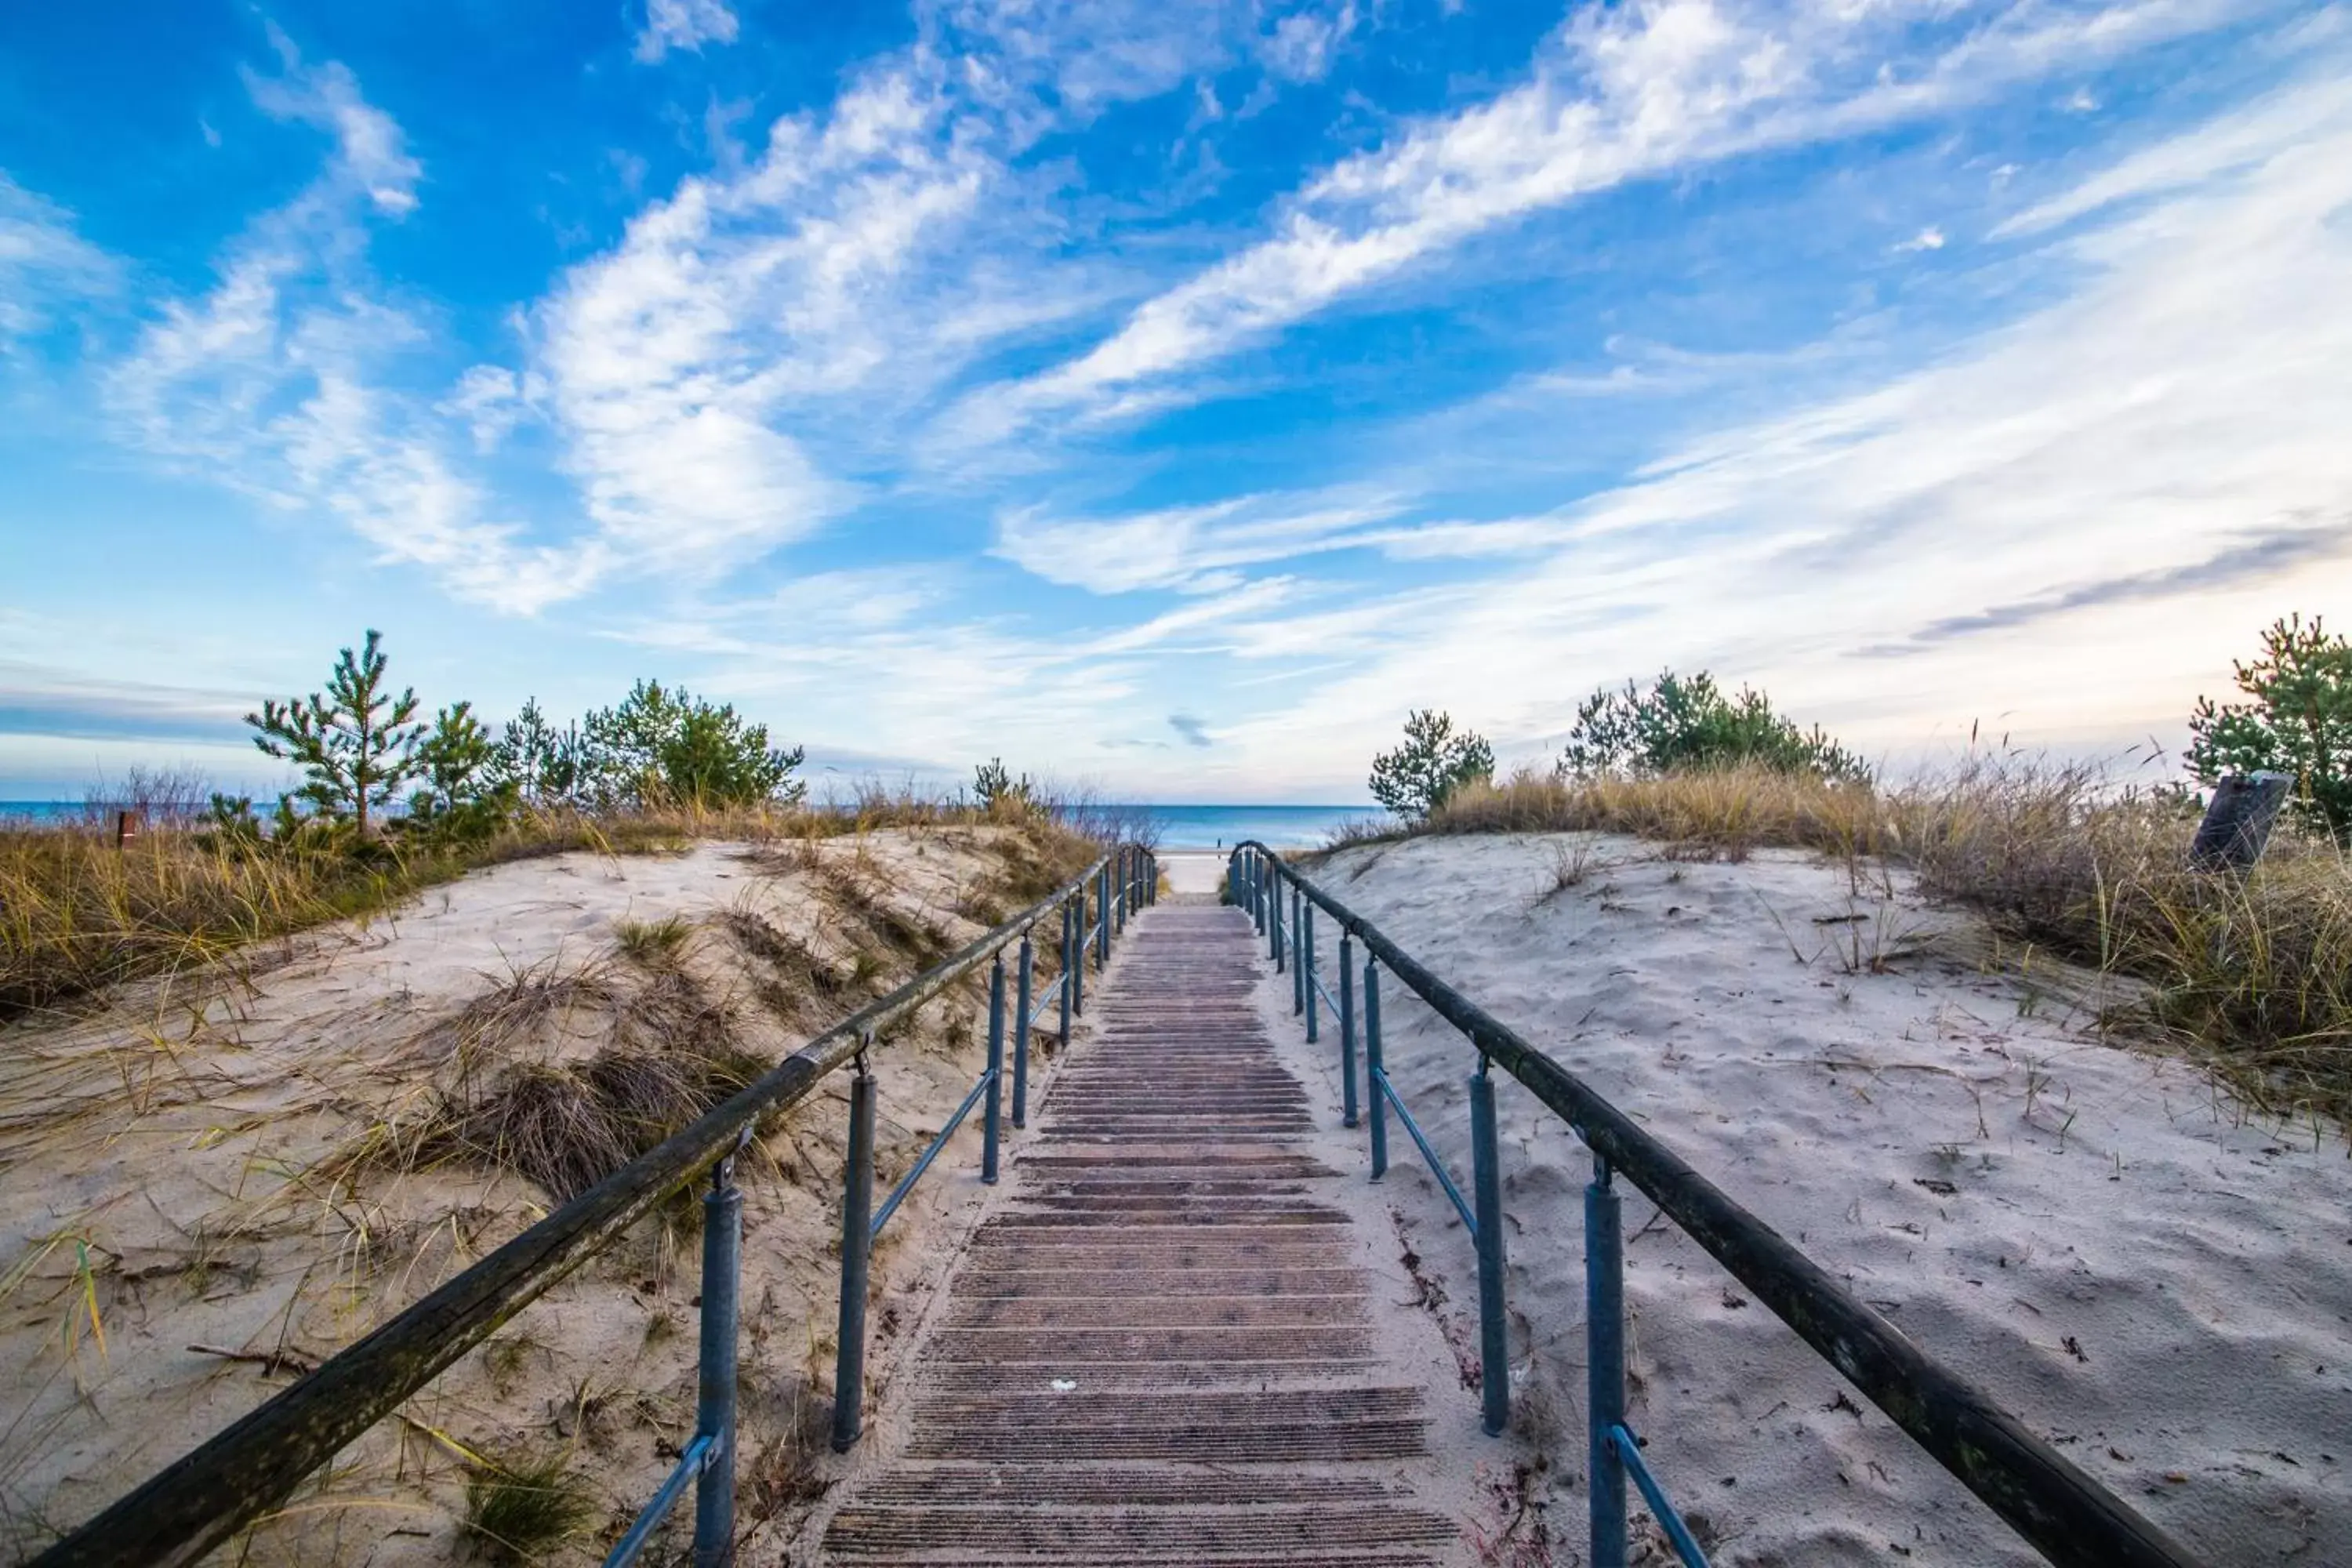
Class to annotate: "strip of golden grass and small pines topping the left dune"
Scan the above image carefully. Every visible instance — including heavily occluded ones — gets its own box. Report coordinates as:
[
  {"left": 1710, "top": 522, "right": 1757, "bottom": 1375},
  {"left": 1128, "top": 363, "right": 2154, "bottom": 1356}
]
[{"left": 0, "top": 633, "right": 1150, "bottom": 1020}]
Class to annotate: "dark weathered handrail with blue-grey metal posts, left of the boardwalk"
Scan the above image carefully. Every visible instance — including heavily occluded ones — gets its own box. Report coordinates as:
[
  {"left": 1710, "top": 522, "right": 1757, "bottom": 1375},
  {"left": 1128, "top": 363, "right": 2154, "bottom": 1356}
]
[{"left": 33, "top": 844, "right": 1157, "bottom": 1568}]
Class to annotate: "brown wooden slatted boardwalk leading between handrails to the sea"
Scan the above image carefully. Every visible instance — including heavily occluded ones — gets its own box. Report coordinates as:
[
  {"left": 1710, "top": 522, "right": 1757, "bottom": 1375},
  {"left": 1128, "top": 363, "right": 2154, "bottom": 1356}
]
[{"left": 823, "top": 905, "right": 1458, "bottom": 1568}]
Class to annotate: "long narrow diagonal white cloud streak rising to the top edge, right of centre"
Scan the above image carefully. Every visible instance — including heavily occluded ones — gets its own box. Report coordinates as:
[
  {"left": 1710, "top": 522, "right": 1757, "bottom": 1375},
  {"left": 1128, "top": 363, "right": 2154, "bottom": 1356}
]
[{"left": 967, "top": 0, "right": 2241, "bottom": 435}]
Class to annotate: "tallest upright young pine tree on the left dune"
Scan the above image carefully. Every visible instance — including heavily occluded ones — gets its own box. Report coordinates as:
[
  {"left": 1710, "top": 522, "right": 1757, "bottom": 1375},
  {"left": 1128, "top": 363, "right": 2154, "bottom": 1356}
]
[{"left": 245, "top": 630, "right": 426, "bottom": 839}]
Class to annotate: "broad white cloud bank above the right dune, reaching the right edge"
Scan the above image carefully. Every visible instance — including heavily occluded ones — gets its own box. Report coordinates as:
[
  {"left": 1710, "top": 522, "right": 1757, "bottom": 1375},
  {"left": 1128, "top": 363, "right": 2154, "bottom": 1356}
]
[{"left": 1223, "top": 65, "right": 2352, "bottom": 785}]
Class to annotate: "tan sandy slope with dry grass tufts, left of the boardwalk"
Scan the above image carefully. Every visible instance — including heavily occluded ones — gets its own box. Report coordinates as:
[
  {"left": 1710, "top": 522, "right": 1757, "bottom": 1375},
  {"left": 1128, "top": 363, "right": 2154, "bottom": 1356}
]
[{"left": 0, "top": 829, "right": 1077, "bottom": 1563}]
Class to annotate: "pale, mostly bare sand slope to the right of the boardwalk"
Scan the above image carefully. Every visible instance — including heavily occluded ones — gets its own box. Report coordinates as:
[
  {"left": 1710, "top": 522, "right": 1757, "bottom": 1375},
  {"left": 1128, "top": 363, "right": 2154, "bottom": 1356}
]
[{"left": 1263, "top": 834, "right": 2352, "bottom": 1568}]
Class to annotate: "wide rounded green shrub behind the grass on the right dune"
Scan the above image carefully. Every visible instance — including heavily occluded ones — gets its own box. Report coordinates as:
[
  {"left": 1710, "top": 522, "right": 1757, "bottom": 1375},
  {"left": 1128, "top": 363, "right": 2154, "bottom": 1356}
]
[{"left": 1559, "top": 670, "right": 1870, "bottom": 783}]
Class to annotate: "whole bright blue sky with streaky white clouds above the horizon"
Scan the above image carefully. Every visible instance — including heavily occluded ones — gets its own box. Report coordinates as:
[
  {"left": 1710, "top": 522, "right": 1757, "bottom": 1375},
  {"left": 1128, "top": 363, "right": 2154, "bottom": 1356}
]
[{"left": 0, "top": 0, "right": 2352, "bottom": 799}]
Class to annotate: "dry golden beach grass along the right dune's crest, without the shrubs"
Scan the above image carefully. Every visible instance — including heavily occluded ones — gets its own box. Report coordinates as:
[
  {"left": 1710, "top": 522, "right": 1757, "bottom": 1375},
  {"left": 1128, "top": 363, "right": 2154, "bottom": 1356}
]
[{"left": 1383, "top": 757, "right": 2352, "bottom": 1126}]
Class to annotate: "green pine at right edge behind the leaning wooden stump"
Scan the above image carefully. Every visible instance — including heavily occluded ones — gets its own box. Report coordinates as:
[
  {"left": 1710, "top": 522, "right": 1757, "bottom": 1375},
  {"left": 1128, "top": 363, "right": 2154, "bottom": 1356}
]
[{"left": 2187, "top": 614, "right": 2352, "bottom": 839}]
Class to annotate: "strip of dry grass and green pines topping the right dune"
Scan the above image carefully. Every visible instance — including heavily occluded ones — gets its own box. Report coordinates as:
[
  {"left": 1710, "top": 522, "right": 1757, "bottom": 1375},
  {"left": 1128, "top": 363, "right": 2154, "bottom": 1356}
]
[{"left": 1350, "top": 621, "right": 2352, "bottom": 1142}]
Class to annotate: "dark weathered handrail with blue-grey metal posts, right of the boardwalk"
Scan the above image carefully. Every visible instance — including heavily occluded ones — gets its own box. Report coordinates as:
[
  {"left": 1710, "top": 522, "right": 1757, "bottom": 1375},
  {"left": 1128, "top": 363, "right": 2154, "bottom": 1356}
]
[{"left": 1232, "top": 839, "right": 2197, "bottom": 1568}]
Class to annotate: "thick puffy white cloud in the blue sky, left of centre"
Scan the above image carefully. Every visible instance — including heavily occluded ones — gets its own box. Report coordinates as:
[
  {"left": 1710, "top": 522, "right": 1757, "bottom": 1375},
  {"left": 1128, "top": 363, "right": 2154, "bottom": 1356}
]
[{"left": 534, "top": 61, "right": 995, "bottom": 569}]
